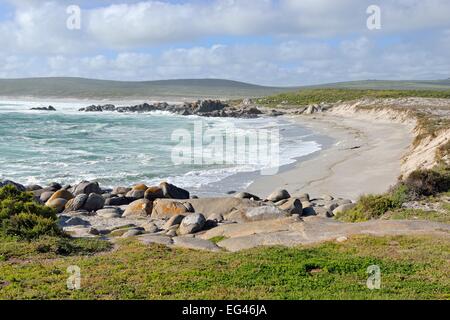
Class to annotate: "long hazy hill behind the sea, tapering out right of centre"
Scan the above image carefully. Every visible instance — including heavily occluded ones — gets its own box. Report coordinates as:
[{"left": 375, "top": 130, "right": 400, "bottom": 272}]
[{"left": 0, "top": 78, "right": 296, "bottom": 99}]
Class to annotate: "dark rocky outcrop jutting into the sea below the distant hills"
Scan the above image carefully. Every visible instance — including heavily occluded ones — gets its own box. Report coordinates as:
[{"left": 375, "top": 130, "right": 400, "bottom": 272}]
[{"left": 79, "top": 100, "right": 262, "bottom": 118}]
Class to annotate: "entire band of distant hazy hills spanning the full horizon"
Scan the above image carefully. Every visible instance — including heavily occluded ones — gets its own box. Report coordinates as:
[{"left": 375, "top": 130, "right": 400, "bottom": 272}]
[{"left": 0, "top": 77, "right": 450, "bottom": 99}]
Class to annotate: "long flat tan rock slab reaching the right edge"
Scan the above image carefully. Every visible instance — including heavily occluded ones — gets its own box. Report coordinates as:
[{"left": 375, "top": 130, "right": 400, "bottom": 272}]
[{"left": 215, "top": 217, "right": 450, "bottom": 252}]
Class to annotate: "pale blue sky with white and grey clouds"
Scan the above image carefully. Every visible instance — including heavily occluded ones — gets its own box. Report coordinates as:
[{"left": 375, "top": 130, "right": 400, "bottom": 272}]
[{"left": 0, "top": 0, "right": 450, "bottom": 86}]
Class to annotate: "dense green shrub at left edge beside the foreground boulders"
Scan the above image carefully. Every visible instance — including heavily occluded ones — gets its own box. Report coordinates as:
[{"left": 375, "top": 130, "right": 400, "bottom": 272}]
[{"left": 0, "top": 185, "right": 61, "bottom": 240}]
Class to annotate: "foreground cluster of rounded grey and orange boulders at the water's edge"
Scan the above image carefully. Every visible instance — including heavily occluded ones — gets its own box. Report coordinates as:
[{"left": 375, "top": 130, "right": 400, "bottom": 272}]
[{"left": 0, "top": 181, "right": 354, "bottom": 250}]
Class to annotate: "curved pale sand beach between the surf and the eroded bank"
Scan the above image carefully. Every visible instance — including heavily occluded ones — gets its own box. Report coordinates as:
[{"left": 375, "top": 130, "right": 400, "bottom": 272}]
[{"left": 247, "top": 114, "right": 413, "bottom": 200}]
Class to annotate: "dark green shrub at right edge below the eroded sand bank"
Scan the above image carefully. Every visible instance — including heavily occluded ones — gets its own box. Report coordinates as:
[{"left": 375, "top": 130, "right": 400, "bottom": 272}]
[{"left": 405, "top": 169, "right": 450, "bottom": 196}]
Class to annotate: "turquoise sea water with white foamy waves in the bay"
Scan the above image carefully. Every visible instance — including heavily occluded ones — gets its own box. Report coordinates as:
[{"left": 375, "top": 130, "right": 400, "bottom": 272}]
[{"left": 0, "top": 101, "right": 321, "bottom": 194}]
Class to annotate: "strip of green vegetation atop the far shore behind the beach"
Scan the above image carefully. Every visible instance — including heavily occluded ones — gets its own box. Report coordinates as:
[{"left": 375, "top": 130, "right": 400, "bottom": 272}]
[{"left": 257, "top": 89, "right": 450, "bottom": 107}]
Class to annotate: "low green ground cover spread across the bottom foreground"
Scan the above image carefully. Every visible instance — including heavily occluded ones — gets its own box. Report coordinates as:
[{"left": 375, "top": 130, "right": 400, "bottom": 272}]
[{"left": 0, "top": 237, "right": 450, "bottom": 299}]
